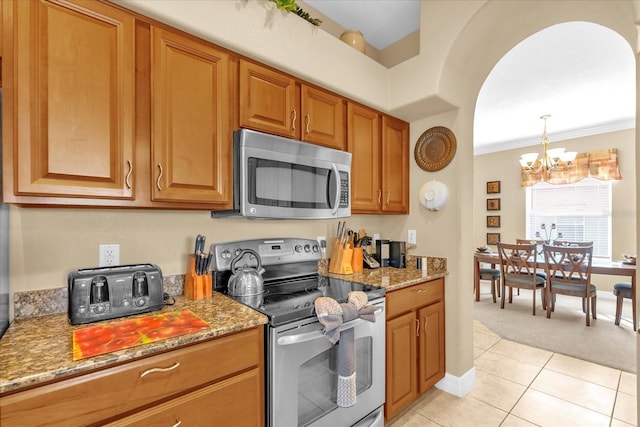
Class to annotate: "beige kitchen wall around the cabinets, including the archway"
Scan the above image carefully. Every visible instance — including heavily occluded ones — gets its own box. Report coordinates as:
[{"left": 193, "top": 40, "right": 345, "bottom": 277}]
[{"left": 10, "top": 0, "right": 640, "bottom": 392}]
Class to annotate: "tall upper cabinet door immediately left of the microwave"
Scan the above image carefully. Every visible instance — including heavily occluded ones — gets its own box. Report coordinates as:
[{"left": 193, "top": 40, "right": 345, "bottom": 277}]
[{"left": 151, "top": 27, "right": 232, "bottom": 205}]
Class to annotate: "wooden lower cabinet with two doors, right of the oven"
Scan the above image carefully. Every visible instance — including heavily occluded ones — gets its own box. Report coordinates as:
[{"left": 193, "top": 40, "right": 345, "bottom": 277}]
[{"left": 384, "top": 278, "right": 445, "bottom": 420}]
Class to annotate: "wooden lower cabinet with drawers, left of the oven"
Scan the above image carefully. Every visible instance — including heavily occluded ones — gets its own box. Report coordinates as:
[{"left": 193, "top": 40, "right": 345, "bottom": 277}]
[{"left": 0, "top": 327, "right": 264, "bottom": 427}]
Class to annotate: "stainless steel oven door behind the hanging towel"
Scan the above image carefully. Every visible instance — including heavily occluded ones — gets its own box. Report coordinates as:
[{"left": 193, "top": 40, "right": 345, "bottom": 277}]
[{"left": 267, "top": 299, "right": 385, "bottom": 427}]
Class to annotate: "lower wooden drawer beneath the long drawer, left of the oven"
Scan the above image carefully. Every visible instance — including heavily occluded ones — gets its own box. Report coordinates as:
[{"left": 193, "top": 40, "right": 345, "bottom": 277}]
[{"left": 105, "top": 369, "right": 264, "bottom": 427}]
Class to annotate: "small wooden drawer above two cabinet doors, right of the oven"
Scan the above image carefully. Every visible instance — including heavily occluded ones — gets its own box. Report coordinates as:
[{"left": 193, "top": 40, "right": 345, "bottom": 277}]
[{"left": 386, "top": 278, "right": 444, "bottom": 319}]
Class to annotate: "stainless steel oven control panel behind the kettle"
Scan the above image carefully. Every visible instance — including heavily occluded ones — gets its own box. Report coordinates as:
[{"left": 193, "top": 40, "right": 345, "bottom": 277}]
[{"left": 211, "top": 237, "right": 322, "bottom": 271}]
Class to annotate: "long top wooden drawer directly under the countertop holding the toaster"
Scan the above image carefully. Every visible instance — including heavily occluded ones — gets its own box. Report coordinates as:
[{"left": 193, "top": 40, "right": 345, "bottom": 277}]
[{"left": 0, "top": 328, "right": 263, "bottom": 426}]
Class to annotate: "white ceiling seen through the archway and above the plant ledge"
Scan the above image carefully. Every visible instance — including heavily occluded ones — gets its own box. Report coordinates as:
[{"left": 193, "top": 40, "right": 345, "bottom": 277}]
[{"left": 305, "top": 0, "right": 636, "bottom": 154}]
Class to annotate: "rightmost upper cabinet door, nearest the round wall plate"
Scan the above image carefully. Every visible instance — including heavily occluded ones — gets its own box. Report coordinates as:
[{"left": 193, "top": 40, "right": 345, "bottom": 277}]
[{"left": 382, "top": 116, "right": 409, "bottom": 214}]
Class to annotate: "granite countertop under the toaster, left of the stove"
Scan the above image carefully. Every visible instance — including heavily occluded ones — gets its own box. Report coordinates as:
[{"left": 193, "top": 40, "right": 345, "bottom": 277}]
[{"left": 0, "top": 292, "right": 268, "bottom": 394}]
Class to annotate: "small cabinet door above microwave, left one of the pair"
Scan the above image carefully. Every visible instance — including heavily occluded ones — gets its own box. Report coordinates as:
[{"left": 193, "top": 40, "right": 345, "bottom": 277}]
[{"left": 239, "top": 60, "right": 300, "bottom": 138}]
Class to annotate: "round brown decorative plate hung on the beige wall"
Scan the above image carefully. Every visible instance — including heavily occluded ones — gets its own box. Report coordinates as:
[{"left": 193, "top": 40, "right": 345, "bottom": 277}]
[{"left": 413, "top": 126, "right": 456, "bottom": 172}]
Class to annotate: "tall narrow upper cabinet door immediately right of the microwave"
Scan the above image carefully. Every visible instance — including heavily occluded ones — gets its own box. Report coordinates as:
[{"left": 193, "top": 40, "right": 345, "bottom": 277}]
[{"left": 347, "top": 103, "right": 382, "bottom": 213}]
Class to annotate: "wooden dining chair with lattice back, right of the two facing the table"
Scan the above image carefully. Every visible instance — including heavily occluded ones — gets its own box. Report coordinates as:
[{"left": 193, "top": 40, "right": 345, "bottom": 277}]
[{"left": 544, "top": 245, "right": 597, "bottom": 326}]
